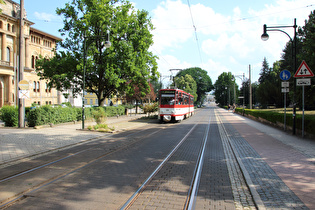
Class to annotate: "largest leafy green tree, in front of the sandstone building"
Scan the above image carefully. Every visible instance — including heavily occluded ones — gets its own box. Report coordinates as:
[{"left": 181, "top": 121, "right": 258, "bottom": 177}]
[{"left": 37, "top": 0, "right": 158, "bottom": 105}]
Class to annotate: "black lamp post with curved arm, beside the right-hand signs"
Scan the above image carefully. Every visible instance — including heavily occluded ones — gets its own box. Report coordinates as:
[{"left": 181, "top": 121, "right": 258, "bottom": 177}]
[{"left": 261, "top": 18, "right": 297, "bottom": 135}]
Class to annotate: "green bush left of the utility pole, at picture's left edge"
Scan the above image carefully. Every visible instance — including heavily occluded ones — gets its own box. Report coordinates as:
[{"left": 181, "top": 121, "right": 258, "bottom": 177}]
[{"left": 0, "top": 106, "right": 19, "bottom": 127}]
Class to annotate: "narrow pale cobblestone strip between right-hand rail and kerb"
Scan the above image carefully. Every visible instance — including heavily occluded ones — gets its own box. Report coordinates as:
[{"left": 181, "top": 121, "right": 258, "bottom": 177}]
[{"left": 216, "top": 110, "right": 261, "bottom": 209}]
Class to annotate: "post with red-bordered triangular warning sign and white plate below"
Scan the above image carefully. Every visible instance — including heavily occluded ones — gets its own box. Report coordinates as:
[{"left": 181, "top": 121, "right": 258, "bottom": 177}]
[{"left": 294, "top": 61, "right": 314, "bottom": 138}]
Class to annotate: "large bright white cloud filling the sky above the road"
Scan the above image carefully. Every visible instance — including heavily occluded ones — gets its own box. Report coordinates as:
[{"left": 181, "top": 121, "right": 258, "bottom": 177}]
[{"left": 152, "top": 0, "right": 315, "bottom": 83}]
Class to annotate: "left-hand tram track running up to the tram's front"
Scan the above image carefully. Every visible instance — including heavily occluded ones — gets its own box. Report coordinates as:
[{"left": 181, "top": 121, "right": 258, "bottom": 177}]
[{"left": 0, "top": 121, "right": 172, "bottom": 209}]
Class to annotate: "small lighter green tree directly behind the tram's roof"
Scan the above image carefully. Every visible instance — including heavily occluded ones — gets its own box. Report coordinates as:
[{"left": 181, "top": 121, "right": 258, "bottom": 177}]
[{"left": 175, "top": 74, "right": 198, "bottom": 102}]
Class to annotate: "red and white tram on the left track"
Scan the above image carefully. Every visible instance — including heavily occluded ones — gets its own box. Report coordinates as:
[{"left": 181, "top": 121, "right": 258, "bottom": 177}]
[{"left": 158, "top": 89, "right": 194, "bottom": 122}]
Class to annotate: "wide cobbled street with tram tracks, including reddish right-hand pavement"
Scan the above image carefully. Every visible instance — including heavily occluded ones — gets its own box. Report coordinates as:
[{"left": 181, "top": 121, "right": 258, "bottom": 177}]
[{"left": 0, "top": 105, "right": 315, "bottom": 209}]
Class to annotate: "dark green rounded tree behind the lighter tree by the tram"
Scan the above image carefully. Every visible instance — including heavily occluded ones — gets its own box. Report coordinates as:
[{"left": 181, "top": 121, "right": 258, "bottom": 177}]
[{"left": 176, "top": 67, "right": 213, "bottom": 103}]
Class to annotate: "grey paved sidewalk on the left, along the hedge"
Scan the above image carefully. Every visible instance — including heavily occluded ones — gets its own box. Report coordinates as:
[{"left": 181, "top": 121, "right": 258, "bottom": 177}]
[{"left": 0, "top": 114, "right": 145, "bottom": 168}]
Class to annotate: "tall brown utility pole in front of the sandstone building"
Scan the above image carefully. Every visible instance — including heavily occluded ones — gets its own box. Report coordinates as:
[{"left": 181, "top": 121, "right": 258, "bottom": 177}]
[{"left": 18, "top": 0, "right": 25, "bottom": 128}]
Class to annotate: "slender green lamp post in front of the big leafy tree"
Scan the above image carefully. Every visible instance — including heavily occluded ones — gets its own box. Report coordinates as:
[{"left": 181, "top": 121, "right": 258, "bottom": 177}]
[{"left": 82, "top": 31, "right": 111, "bottom": 130}]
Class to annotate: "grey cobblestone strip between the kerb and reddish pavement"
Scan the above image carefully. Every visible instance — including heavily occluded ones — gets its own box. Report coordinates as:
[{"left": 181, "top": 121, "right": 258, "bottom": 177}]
[{"left": 222, "top": 112, "right": 308, "bottom": 209}]
